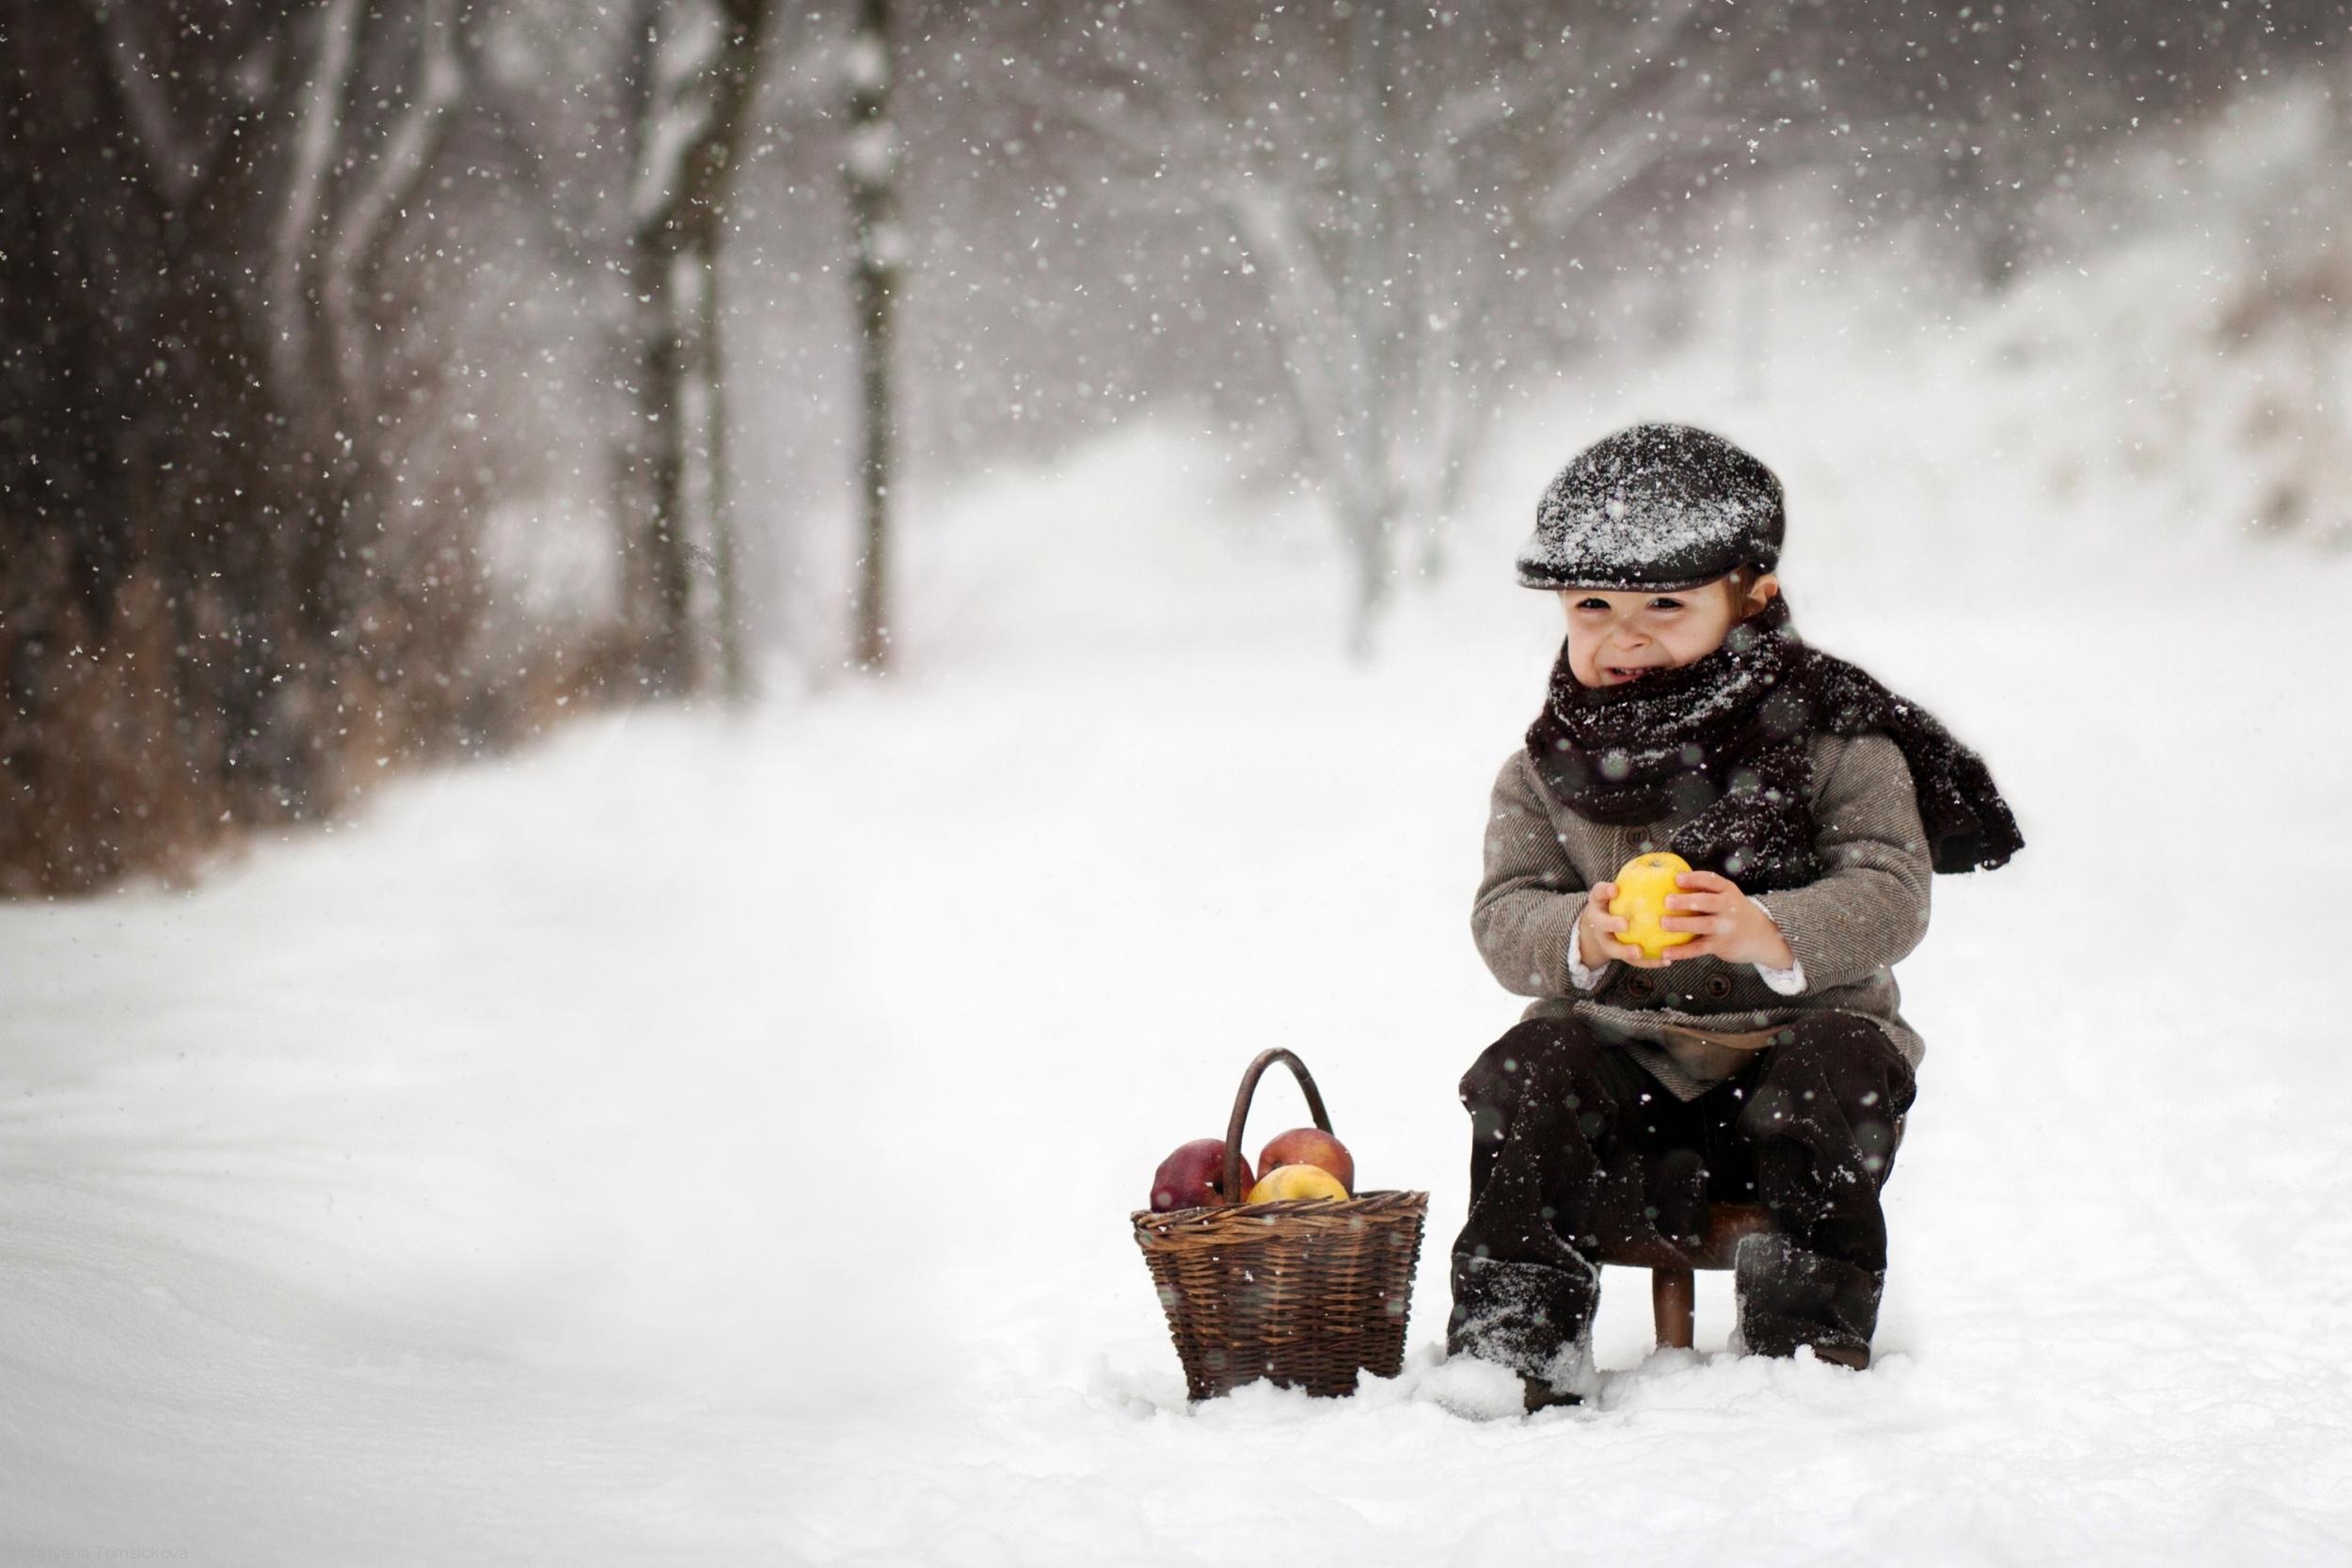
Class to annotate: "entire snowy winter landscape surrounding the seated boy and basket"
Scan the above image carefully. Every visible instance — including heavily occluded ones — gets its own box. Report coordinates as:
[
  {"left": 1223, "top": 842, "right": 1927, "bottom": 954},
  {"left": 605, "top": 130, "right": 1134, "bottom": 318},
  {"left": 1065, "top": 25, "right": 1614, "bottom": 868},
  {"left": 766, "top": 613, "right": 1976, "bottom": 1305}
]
[{"left": 0, "top": 0, "right": 2352, "bottom": 1563}]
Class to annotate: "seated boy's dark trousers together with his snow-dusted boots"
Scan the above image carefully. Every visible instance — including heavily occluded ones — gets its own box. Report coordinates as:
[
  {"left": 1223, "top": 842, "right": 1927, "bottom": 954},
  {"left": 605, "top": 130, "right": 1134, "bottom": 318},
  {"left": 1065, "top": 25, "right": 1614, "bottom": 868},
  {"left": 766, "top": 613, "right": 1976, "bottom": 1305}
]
[{"left": 1447, "top": 1011, "right": 1917, "bottom": 1373}]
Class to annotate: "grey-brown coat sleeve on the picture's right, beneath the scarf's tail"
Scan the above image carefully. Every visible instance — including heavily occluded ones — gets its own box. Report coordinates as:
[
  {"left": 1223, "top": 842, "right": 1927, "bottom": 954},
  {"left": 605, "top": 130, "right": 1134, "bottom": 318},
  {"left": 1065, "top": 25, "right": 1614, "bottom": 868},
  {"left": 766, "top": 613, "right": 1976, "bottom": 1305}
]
[{"left": 1762, "top": 731, "right": 1933, "bottom": 990}]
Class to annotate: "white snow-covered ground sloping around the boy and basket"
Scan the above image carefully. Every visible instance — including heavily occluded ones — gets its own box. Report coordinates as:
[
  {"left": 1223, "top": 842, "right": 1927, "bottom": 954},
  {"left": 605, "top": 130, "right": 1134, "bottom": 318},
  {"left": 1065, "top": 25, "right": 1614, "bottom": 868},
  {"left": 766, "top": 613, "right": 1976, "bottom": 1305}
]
[{"left": 0, "top": 107, "right": 2352, "bottom": 1568}]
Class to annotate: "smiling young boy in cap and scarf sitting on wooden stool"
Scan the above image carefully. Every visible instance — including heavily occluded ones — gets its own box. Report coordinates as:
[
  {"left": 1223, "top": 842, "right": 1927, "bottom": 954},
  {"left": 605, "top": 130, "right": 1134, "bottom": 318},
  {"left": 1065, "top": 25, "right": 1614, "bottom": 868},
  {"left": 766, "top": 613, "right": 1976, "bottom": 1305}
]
[{"left": 1447, "top": 423, "right": 2023, "bottom": 1411}]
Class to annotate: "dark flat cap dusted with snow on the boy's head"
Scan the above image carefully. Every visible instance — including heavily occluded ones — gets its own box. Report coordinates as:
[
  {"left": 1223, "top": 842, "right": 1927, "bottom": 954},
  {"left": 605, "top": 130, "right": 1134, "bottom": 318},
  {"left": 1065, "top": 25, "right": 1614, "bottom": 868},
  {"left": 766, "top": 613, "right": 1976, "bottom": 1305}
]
[{"left": 1519, "top": 420, "right": 1788, "bottom": 593}]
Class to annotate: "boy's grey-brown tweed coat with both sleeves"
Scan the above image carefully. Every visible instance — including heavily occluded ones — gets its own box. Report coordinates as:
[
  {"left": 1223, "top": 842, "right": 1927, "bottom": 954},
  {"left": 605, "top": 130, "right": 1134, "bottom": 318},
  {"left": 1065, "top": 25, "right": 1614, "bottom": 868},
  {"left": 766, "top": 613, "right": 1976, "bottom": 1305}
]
[{"left": 1470, "top": 731, "right": 1933, "bottom": 1101}]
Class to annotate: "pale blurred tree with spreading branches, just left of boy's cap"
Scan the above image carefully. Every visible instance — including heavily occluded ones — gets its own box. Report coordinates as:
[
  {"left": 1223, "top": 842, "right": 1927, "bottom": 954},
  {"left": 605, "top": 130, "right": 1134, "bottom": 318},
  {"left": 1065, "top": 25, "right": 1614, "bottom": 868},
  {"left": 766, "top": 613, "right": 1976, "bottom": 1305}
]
[{"left": 1005, "top": 0, "right": 1778, "bottom": 654}]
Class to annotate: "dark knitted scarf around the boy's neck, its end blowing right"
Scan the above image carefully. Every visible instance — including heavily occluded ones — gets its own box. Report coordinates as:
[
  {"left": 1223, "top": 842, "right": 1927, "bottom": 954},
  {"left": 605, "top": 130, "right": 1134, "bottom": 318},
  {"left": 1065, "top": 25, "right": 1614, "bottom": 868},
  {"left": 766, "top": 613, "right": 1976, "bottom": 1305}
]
[{"left": 1527, "top": 597, "right": 2026, "bottom": 894}]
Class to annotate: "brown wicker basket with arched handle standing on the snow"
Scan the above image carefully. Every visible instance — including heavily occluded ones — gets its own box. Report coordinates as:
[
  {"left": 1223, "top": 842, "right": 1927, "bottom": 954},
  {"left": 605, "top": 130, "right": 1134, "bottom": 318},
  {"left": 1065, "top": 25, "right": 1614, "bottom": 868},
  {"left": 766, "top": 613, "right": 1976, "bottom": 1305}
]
[{"left": 1134, "top": 1049, "right": 1430, "bottom": 1399}]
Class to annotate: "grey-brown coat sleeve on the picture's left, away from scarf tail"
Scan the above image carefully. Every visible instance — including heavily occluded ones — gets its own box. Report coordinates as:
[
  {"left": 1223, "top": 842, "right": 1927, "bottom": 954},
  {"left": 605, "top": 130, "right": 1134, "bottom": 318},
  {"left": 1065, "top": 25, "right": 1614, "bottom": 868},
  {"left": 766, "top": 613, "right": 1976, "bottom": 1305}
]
[{"left": 1470, "top": 752, "right": 1616, "bottom": 997}]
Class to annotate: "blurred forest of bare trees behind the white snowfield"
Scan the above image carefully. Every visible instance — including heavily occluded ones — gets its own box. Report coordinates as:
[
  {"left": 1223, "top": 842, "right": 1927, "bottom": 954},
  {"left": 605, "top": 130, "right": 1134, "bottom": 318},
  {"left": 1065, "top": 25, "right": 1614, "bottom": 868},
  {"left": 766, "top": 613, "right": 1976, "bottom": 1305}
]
[{"left": 0, "top": 0, "right": 2352, "bottom": 894}]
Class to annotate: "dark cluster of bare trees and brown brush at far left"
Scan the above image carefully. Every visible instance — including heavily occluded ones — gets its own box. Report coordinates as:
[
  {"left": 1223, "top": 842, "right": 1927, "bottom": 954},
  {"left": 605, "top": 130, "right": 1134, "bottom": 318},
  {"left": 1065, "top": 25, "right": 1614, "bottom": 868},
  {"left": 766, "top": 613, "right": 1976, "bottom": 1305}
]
[{"left": 0, "top": 0, "right": 473, "bottom": 891}]
